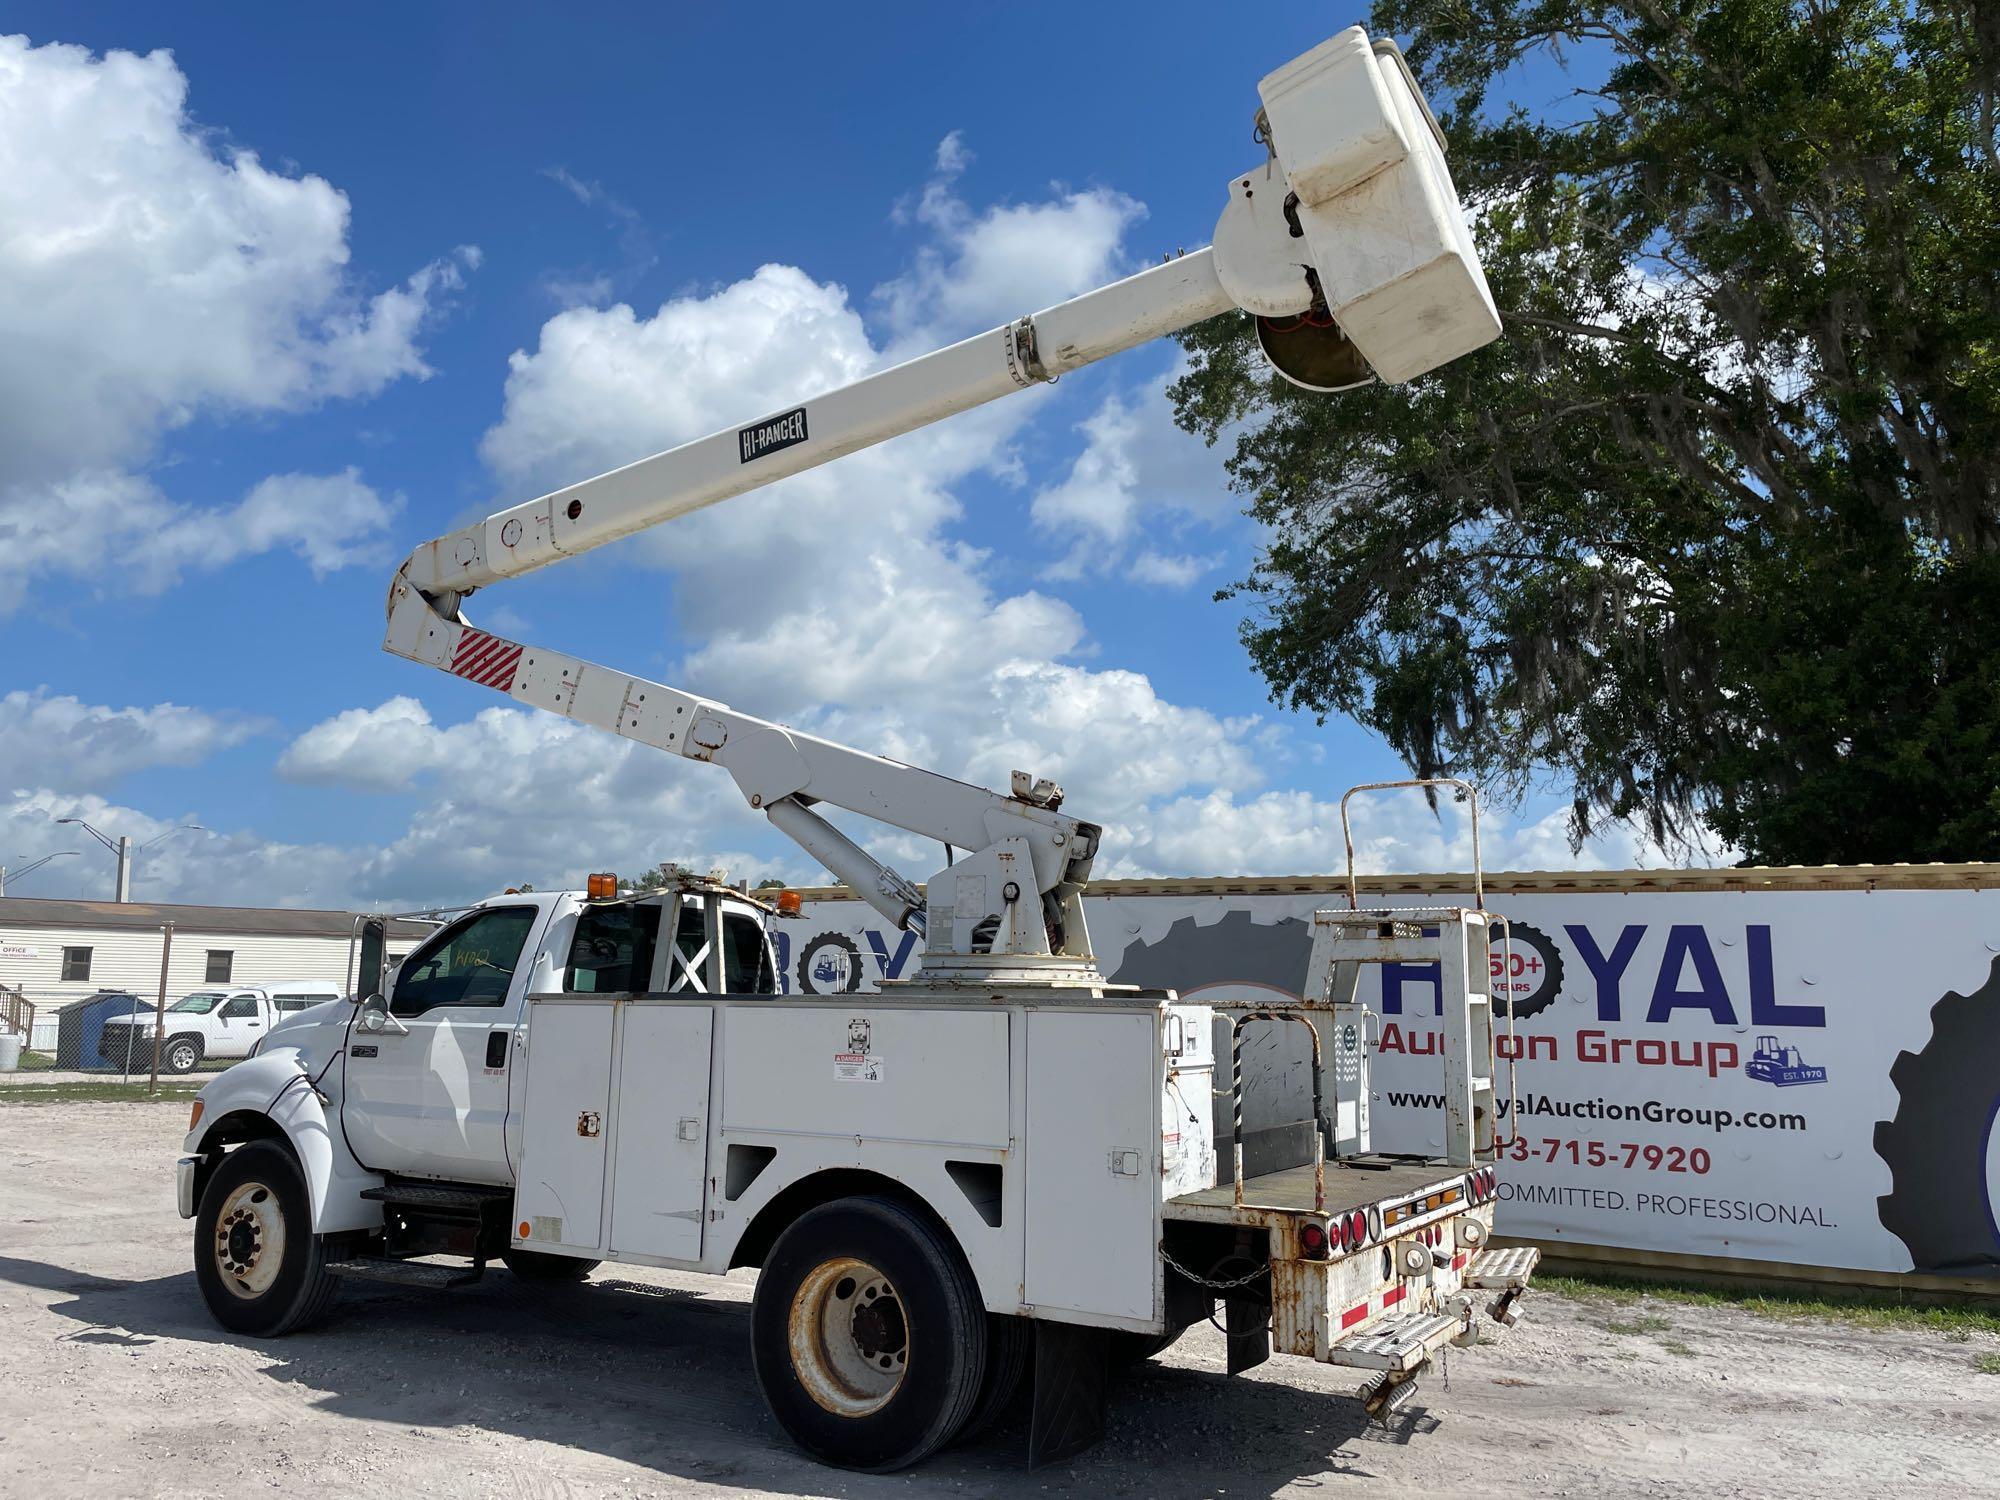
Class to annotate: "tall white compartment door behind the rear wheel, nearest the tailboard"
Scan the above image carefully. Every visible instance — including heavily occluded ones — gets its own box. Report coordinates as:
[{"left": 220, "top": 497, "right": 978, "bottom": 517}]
[{"left": 1024, "top": 1010, "right": 1162, "bottom": 1328}]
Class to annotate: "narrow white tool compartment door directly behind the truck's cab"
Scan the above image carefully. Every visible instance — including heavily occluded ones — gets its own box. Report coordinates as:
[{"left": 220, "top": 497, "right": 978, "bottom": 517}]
[{"left": 514, "top": 998, "right": 616, "bottom": 1250}]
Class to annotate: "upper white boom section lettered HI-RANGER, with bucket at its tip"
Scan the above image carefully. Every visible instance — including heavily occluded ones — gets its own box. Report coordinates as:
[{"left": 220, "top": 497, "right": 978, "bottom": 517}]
[{"left": 400, "top": 26, "right": 1500, "bottom": 612}]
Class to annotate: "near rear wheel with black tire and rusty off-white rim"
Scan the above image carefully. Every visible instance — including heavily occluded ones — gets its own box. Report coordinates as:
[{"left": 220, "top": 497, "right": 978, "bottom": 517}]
[{"left": 750, "top": 1198, "right": 986, "bottom": 1474}]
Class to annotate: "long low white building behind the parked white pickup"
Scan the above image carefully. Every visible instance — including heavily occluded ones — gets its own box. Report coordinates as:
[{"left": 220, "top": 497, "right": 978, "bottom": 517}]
[{"left": 0, "top": 896, "right": 430, "bottom": 1010}]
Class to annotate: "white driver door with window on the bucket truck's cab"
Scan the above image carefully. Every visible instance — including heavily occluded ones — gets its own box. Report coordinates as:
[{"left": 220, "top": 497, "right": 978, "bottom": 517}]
[{"left": 340, "top": 906, "right": 544, "bottom": 1186}]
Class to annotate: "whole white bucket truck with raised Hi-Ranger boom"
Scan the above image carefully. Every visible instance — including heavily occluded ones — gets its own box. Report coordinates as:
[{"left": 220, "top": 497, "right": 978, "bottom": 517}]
[{"left": 180, "top": 28, "right": 1532, "bottom": 1470}]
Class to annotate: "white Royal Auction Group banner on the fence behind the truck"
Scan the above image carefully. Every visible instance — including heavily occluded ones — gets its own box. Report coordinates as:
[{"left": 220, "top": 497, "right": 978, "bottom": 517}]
[{"left": 778, "top": 868, "right": 2000, "bottom": 1276}]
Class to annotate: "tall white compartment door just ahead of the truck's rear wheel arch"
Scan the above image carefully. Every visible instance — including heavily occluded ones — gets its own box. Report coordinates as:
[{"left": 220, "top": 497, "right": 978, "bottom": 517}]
[{"left": 612, "top": 1000, "right": 716, "bottom": 1260}]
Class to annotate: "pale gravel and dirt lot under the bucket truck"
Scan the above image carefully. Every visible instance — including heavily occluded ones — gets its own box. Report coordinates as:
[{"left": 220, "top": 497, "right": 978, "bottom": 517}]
[{"left": 0, "top": 1104, "right": 2000, "bottom": 1500}]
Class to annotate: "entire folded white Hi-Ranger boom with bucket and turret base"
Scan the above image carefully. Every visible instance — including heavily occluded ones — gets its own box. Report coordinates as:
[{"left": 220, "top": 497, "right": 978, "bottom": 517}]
[{"left": 384, "top": 26, "right": 1500, "bottom": 984}]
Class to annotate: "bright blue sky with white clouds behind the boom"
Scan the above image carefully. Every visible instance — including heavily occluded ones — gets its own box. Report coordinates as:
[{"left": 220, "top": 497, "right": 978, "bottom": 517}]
[{"left": 0, "top": 4, "right": 1634, "bottom": 904}]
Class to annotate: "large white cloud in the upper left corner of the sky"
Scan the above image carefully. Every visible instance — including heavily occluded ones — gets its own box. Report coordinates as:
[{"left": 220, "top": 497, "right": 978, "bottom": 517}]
[{"left": 0, "top": 36, "right": 478, "bottom": 612}]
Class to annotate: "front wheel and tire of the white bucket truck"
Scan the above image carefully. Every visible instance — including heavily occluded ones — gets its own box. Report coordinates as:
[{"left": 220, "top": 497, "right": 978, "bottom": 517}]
[{"left": 194, "top": 1140, "right": 340, "bottom": 1338}]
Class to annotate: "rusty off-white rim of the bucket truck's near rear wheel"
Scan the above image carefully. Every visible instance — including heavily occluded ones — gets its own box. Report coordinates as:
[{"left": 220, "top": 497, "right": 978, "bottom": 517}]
[{"left": 788, "top": 1256, "right": 910, "bottom": 1418}]
